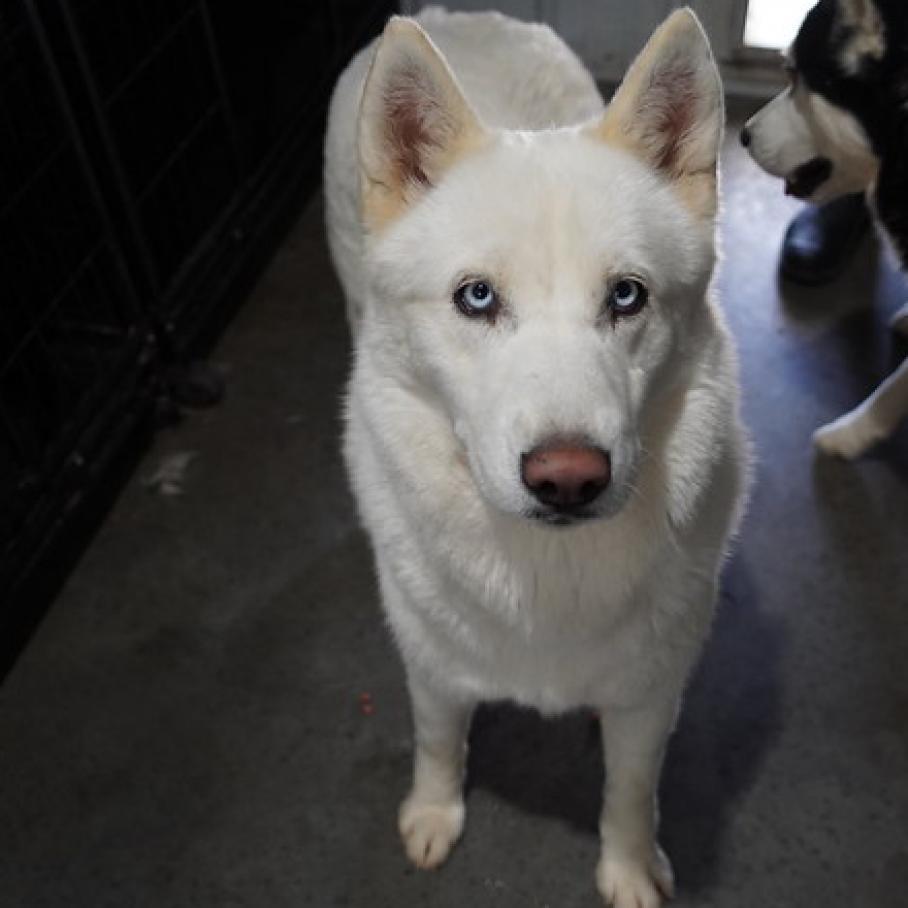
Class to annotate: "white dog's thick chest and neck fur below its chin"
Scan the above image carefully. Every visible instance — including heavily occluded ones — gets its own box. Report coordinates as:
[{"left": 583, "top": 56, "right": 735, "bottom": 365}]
[{"left": 347, "top": 369, "right": 736, "bottom": 712}]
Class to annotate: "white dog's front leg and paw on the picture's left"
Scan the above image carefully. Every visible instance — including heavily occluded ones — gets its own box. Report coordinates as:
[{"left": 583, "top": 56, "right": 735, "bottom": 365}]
[{"left": 398, "top": 671, "right": 474, "bottom": 869}]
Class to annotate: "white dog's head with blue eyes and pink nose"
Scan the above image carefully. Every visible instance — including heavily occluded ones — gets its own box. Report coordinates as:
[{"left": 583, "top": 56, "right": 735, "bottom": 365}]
[{"left": 359, "top": 11, "right": 723, "bottom": 524}]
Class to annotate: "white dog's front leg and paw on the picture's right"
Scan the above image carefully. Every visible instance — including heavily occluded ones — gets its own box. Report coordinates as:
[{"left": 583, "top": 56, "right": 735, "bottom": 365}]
[{"left": 596, "top": 694, "right": 678, "bottom": 908}]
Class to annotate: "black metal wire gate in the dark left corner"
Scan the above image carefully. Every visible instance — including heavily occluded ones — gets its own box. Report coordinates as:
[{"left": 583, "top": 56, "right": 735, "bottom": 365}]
[{"left": 0, "top": 0, "right": 391, "bottom": 660}]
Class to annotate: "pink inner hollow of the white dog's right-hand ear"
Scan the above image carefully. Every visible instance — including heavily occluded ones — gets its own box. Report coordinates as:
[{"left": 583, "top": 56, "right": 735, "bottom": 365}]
[{"left": 642, "top": 63, "right": 697, "bottom": 171}]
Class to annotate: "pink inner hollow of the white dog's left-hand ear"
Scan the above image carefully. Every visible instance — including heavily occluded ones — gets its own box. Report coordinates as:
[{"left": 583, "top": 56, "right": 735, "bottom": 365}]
[{"left": 384, "top": 67, "right": 443, "bottom": 186}]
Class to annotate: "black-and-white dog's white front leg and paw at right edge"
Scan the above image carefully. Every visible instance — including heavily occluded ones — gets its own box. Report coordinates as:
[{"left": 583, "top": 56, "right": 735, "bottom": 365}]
[{"left": 813, "top": 359, "right": 908, "bottom": 460}]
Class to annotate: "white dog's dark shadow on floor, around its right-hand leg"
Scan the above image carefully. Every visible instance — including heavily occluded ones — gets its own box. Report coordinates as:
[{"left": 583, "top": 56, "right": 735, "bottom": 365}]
[{"left": 467, "top": 559, "right": 783, "bottom": 892}]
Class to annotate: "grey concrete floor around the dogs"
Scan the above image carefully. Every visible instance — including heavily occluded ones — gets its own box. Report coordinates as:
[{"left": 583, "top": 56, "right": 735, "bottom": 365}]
[{"left": 0, "top": 122, "right": 908, "bottom": 908}]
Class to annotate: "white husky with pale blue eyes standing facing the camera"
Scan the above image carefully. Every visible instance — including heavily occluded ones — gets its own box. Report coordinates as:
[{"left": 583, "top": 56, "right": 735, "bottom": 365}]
[{"left": 325, "top": 10, "right": 746, "bottom": 908}]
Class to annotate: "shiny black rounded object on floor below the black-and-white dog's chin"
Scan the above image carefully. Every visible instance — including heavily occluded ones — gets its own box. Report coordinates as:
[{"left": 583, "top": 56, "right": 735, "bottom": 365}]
[{"left": 779, "top": 193, "right": 870, "bottom": 285}]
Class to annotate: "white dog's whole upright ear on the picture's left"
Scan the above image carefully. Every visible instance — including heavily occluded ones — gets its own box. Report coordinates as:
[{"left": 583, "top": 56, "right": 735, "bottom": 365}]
[{"left": 359, "top": 16, "right": 485, "bottom": 231}]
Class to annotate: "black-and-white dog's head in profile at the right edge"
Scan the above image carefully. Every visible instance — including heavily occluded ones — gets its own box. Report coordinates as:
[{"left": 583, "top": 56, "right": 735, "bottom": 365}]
[{"left": 741, "top": 0, "right": 889, "bottom": 202}]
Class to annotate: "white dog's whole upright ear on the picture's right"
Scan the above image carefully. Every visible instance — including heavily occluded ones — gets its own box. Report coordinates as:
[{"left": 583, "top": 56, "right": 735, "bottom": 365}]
[{"left": 591, "top": 8, "right": 725, "bottom": 218}]
